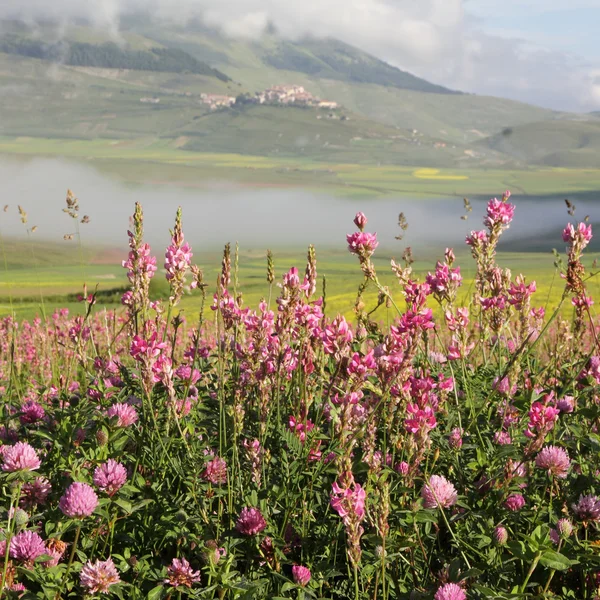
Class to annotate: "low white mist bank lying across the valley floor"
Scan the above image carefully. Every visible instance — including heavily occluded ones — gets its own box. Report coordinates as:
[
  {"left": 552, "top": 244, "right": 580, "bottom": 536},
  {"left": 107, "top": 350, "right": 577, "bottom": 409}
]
[{"left": 0, "top": 158, "right": 598, "bottom": 255}]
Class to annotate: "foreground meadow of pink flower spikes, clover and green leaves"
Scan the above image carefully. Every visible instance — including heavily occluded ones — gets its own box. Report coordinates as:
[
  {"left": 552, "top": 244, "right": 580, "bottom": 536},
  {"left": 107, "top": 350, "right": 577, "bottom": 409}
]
[{"left": 0, "top": 193, "right": 600, "bottom": 600}]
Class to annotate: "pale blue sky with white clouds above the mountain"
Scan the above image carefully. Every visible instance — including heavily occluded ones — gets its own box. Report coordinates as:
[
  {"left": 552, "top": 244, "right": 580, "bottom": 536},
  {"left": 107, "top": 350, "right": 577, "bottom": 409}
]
[{"left": 0, "top": 0, "right": 600, "bottom": 112}]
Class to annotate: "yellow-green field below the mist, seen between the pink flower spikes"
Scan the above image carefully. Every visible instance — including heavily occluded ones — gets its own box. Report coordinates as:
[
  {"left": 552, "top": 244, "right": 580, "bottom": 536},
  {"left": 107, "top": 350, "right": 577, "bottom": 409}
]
[{"left": 0, "top": 238, "right": 600, "bottom": 326}]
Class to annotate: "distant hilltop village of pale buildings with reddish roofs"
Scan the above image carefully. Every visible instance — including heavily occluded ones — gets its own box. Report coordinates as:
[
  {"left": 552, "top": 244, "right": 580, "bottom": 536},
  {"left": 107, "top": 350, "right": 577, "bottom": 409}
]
[{"left": 200, "top": 85, "right": 338, "bottom": 110}]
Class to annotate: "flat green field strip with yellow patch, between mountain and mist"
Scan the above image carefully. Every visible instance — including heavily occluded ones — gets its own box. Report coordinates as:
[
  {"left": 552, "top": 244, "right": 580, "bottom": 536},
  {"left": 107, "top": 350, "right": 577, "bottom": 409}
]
[{"left": 0, "top": 137, "right": 600, "bottom": 198}]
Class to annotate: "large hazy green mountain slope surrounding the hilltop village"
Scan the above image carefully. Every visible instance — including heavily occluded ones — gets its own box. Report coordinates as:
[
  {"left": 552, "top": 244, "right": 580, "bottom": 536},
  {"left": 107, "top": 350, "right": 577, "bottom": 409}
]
[{"left": 0, "top": 18, "right": 598, "bottom": 167}]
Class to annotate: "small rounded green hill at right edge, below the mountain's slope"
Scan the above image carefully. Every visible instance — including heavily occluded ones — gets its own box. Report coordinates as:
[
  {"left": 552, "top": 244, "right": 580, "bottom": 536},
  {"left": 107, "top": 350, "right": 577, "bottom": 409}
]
[{"left": 480, "top": 119, "right": 600, "bottom": 169}]
